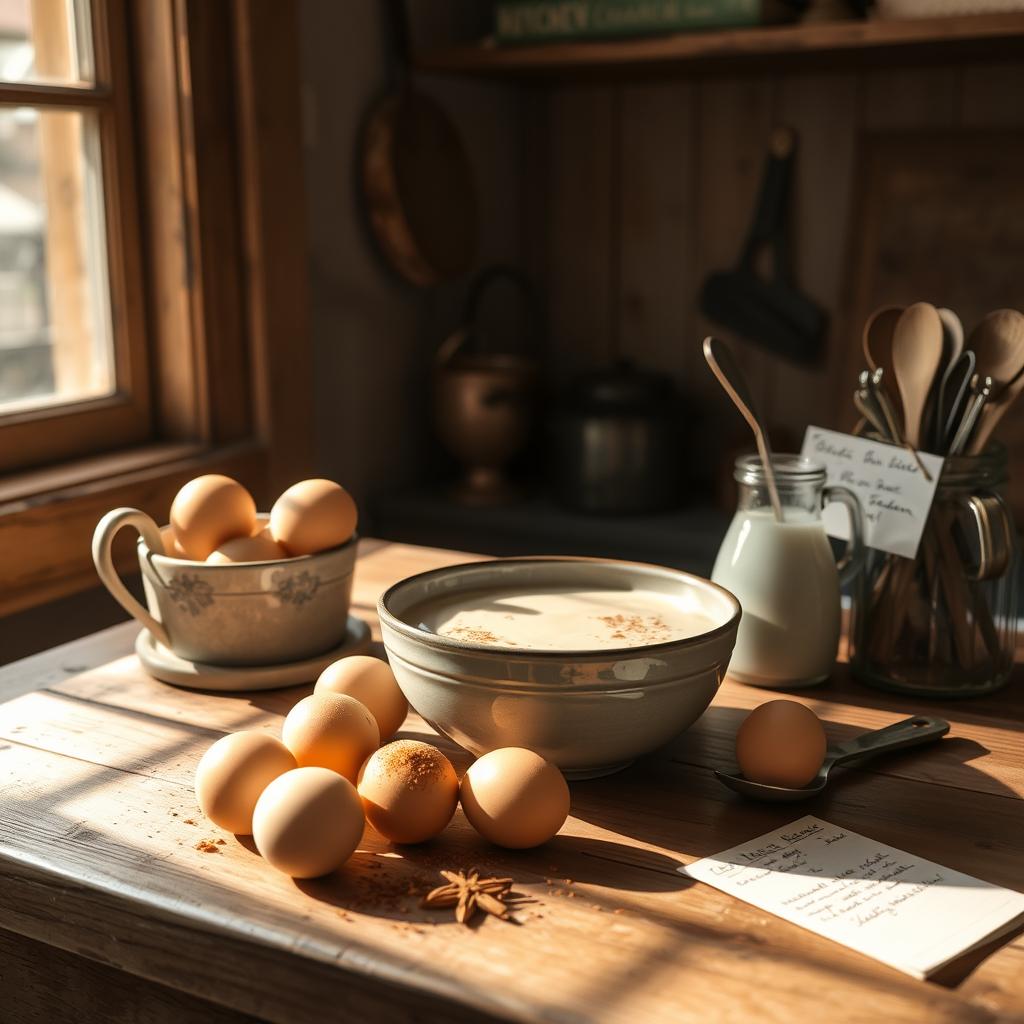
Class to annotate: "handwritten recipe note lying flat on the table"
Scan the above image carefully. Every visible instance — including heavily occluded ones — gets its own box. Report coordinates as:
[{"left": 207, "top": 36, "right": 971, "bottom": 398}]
[{"left": 679, "top": 815, "right": 1024, "bottom": 978}]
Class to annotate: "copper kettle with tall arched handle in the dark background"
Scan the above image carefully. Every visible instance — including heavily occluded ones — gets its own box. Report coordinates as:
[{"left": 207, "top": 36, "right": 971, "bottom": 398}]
[{"left": 433, "top": 266, "right": 538, "bottom": 505}]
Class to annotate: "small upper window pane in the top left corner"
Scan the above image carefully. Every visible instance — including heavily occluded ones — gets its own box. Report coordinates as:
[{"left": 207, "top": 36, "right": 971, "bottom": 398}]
[{"left": 0, "top": 0, "right": 93, "bottom": 85}]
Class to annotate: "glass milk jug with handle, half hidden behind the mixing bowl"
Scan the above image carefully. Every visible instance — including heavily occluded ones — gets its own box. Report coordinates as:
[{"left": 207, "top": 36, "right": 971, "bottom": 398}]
[{"left": 712, "top": 455, "right": 862, "bottom": 688}]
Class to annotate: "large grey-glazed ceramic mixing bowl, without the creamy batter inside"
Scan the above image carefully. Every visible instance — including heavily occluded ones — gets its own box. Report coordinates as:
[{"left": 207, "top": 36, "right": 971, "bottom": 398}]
[{"left": 378, "top": 557, "right": 740, "bottom": 778}]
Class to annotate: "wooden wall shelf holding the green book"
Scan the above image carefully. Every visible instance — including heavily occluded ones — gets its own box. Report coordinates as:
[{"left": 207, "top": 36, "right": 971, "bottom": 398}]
[{"left": 415, "top": 13, "right": 1024, "bottom": 79}]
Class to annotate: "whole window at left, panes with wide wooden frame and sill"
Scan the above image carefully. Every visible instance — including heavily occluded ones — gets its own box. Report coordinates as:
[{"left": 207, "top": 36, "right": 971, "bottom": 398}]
[{"left": 0, "top": 0, "right": 312, "bottom": 614}]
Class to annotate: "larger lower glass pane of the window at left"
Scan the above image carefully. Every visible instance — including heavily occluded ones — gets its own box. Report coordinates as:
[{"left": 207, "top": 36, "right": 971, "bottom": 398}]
[{"left": 0, "top": 106, "right": 116, "bottom": 415}]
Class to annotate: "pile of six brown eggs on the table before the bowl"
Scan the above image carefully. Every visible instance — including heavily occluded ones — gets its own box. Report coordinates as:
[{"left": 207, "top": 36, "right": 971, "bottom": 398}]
[{"left": 196, "top": 655, "right": 569, "bottom": 879}]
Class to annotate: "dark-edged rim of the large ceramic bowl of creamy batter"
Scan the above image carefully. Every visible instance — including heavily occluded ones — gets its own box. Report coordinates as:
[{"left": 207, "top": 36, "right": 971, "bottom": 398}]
[{"left": 377, "top": 555, "right": 742, "bottom": 662}]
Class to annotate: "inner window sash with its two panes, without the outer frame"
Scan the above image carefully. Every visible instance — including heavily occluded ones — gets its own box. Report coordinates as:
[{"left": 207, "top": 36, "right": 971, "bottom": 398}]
[{"left": 0, "top": 0, "right": 150, "bottom": 470}]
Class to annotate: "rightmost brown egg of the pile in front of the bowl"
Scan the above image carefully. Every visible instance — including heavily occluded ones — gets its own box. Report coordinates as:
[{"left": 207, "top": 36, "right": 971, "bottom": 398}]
[{"left": 460, "top": 746, "right": 569, "bottom": 850}]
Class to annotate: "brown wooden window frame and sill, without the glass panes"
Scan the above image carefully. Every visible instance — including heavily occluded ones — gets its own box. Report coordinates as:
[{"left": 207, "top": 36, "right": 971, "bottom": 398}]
[{"left": 0, "top": 0, "right": 312, "bottom": 614}]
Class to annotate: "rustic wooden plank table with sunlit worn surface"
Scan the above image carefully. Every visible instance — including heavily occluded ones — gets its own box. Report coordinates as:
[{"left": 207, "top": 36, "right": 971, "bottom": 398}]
[{"left": 0, "top": 542, "right": 1024, "bottom": 1024}]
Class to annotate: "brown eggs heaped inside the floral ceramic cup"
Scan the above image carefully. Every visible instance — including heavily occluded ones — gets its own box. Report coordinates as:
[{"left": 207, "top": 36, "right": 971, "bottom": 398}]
[{"left": 166, "top": 473, "right": 357, "bottom": 564}]
